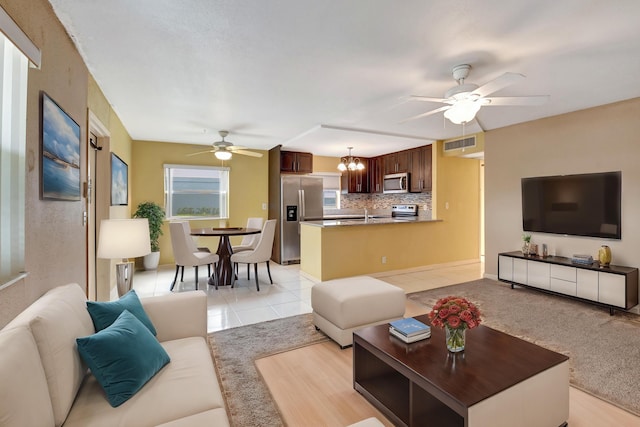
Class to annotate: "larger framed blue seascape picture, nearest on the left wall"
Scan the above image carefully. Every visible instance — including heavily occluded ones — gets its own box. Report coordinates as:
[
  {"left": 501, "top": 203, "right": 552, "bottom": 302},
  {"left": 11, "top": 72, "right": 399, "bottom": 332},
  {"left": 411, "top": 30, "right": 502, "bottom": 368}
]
[{"left": 40, "top": 92, "right": 80, "bottom": 202}]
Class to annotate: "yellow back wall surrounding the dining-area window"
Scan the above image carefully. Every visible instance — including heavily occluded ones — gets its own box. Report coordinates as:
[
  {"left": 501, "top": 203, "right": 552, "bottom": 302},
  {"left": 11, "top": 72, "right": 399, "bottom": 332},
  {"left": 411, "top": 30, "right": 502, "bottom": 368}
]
[{"left": 130, "top": 141, "right": 269, "bottom": 264}]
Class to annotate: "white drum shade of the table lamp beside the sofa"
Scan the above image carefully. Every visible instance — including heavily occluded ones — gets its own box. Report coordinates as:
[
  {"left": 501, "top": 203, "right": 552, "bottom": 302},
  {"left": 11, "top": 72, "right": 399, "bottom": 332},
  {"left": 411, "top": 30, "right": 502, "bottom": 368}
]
[{"left": 98, "top": 218, "right": 151, "bottom": 259}]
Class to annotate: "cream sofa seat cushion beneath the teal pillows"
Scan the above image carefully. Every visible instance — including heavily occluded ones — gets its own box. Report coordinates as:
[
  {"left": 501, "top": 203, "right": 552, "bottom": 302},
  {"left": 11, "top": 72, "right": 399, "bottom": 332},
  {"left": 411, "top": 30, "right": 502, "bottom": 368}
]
[{"left": 65, "top": 337, "right": 224, "bottom": 427}]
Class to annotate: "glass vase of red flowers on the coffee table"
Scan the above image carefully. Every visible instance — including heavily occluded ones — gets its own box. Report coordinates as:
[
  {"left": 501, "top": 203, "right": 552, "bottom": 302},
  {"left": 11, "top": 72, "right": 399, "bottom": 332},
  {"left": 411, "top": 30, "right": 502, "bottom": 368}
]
[{"left": 429, "top": 296, "right": 481, "bottom": 353}]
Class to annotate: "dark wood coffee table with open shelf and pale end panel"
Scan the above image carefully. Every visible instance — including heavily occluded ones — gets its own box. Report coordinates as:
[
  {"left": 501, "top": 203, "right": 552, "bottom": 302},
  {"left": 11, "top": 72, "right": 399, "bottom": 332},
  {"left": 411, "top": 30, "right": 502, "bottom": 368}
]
[{"left": 353, "top": 316, "right": 569, "bottom": 427}]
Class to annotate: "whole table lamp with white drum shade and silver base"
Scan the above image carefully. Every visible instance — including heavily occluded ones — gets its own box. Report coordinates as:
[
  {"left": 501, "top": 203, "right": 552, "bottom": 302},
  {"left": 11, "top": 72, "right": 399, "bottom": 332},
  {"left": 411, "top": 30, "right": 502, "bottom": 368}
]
[{"left": 98, "top": 218, "right": 151, "bottom": 296}]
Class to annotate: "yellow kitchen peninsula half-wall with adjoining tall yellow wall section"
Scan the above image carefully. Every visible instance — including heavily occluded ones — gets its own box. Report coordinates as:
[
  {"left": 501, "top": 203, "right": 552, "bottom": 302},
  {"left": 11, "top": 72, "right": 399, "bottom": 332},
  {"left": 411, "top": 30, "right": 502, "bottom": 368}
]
[{"left": 300, "top": 143, "right": 481, "bottom": 280}]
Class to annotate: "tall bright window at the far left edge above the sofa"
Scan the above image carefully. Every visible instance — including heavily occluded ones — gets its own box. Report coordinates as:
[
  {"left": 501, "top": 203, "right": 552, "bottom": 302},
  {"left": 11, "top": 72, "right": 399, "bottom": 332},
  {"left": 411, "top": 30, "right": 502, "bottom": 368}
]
[{"left": 0, "top": 29, "right": 29, "bottom": 289}]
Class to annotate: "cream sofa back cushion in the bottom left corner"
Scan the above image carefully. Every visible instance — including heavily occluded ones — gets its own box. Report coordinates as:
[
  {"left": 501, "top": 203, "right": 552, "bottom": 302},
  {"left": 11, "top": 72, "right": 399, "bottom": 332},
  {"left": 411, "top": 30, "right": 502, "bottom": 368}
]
[{"left": 0, "top": 326, "right": 53, "bottom": 427}]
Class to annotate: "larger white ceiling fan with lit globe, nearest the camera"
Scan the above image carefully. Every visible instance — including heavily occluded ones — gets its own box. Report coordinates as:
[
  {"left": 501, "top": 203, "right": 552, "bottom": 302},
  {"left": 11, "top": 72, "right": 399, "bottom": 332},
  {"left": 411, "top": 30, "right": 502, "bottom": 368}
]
[{"left": 400, "top": 64, "right": 549, "bottom": 124}]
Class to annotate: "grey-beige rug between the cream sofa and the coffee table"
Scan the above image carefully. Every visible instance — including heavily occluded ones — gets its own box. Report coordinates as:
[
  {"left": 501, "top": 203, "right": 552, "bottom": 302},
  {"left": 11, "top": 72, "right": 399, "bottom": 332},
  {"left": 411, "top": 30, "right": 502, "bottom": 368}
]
[{"left": 209, "top": 314, "right": 328, "bottom": 427}]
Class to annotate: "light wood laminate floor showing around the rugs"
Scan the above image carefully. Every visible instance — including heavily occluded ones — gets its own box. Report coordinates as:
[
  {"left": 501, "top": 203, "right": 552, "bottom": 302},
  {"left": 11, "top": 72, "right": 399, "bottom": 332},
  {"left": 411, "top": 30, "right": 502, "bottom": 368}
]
[{"left": 256, "top": 263, "right": 640, "bottom": 427}]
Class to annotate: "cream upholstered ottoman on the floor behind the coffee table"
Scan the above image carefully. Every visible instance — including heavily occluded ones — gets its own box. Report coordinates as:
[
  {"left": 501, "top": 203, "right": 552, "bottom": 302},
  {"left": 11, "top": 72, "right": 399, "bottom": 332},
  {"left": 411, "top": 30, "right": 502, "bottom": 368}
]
[{"left": 311, "top": 276, "right": 406, "bottom": 348}]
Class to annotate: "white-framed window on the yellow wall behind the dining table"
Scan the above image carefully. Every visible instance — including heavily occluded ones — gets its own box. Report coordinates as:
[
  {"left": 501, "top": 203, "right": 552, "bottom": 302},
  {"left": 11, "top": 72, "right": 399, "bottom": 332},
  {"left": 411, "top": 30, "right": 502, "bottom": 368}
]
[{"left": 164, "top": 165, "right": 229, "bottom": 220}]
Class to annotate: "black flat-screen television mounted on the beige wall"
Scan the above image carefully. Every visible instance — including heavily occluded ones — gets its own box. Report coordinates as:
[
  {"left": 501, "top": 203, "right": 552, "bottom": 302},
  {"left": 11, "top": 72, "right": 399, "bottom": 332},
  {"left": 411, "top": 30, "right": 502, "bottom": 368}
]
[{"left": 522, "top": 171, "right": 622, "bottom": 239}]
